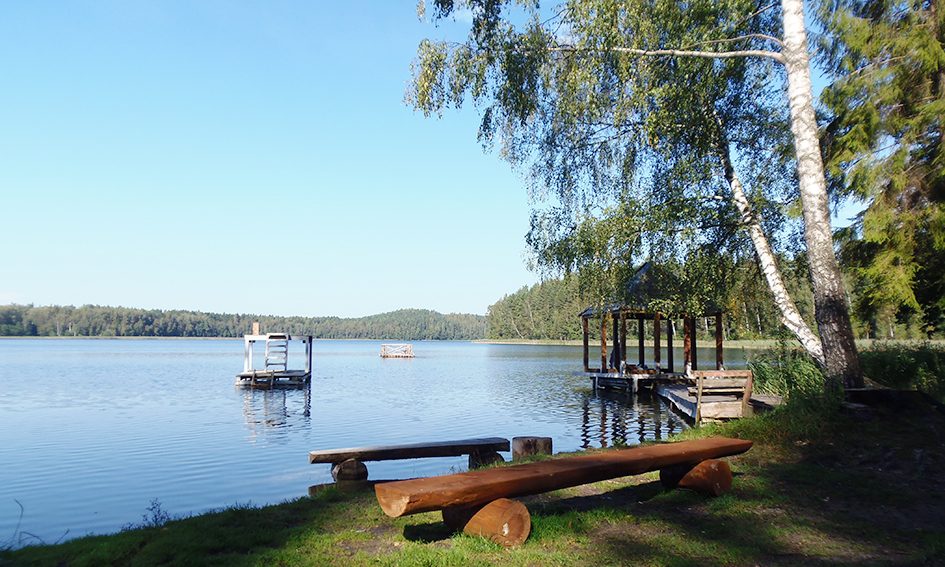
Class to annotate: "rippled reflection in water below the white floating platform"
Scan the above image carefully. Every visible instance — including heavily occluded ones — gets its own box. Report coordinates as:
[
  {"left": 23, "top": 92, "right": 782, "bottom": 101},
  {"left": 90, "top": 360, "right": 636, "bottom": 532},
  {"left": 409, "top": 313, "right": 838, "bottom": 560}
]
[{"left": 240, "top": 384, "right": 312, "bottom": 442}]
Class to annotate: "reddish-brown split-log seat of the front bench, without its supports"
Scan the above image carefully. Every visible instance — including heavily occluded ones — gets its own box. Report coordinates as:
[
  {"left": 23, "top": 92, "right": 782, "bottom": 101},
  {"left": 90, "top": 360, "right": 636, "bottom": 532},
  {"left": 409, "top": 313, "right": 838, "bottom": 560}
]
[{"left": 374, "top": 437, "right": 753, "bottom": 518}]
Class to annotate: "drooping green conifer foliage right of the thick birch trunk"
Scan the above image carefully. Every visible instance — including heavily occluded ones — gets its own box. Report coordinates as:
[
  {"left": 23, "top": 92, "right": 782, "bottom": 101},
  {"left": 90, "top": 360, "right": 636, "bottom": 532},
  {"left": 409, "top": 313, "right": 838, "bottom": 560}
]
[{"left": 820, "top": 0, "right": 945, "bottom": 336}]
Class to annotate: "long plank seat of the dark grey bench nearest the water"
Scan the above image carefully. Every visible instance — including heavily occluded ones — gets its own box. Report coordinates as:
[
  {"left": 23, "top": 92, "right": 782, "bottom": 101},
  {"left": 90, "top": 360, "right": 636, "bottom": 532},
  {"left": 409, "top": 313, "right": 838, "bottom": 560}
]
[{"left": 308, "top": 437, "right": 510, "bottom": 463}]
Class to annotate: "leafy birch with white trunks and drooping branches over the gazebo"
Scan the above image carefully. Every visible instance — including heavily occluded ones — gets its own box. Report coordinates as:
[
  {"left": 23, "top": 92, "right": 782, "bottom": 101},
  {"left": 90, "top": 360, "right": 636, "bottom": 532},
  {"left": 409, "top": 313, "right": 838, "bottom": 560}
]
[{"left": 407, "top": 0, "right": 862, "bottom": 387}]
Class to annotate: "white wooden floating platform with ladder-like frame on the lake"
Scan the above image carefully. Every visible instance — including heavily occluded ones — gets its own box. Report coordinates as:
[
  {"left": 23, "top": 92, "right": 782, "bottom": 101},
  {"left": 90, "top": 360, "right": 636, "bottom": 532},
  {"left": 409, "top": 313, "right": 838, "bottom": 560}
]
[{"left": 236, "top": 336, "right": 312, "bottom": 388}]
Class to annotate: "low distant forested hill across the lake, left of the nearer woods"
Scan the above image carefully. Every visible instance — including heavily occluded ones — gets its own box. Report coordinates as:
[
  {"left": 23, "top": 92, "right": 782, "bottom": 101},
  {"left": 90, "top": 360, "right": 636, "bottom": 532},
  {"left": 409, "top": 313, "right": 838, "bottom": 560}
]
[{"left": 0, "top": 305, "right": 487, "bottom": 341}]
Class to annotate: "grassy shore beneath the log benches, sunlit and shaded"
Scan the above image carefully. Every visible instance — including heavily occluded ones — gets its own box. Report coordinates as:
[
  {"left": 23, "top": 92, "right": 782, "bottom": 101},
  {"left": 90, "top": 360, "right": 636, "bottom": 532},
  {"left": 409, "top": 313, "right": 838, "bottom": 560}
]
[{"left": 0, "top": 394, "right": 945, "bottom": 567}]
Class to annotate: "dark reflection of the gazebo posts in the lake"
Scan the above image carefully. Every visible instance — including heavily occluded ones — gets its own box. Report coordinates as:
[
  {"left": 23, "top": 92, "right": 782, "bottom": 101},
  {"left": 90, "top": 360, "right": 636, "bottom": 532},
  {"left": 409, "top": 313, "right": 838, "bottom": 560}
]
[{"left": 581, "top": 390, "right": 688, "bottom": 449}]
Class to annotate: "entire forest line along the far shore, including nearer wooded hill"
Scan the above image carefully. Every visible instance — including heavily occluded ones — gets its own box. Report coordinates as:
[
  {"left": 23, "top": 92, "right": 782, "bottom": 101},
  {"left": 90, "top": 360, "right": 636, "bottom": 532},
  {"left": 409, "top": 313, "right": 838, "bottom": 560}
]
[{"left": 0, "top": 261, "right": 928, "bottom": 341}]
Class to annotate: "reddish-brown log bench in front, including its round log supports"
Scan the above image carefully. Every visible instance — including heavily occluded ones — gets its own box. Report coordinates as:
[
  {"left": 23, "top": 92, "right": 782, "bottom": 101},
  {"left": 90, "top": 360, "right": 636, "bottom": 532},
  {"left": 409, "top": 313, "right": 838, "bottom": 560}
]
[{"left": 374, "top": 437, "right": 753, "bottom": 546}]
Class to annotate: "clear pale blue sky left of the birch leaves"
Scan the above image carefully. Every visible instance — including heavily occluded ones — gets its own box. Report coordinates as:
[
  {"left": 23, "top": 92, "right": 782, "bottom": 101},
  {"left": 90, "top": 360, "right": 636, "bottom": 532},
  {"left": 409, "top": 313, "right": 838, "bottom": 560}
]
[{"left": 0, "top": 0, "right": 537, "bottom": 317}]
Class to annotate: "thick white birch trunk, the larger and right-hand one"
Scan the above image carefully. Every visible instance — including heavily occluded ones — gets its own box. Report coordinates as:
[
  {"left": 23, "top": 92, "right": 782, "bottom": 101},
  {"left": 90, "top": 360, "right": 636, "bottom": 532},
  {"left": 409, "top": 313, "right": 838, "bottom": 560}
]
[{"left": 781, "top": 0, "right": 863, "bottom": 388}]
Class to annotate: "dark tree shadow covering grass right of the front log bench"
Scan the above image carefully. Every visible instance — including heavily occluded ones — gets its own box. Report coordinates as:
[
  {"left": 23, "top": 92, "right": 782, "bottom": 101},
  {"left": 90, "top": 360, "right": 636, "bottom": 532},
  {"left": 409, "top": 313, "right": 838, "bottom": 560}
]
[{"left": 529, "top": 406, "right": 945, "bottom": 566}]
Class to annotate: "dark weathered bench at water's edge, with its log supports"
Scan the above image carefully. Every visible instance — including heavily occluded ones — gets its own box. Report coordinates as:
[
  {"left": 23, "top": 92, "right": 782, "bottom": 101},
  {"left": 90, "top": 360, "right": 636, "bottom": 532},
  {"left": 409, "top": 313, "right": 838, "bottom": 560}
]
[{"left": 308, "top": 437, "right": 509, "bottom": 480}]
